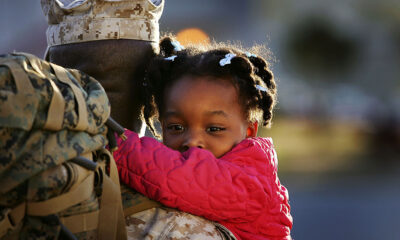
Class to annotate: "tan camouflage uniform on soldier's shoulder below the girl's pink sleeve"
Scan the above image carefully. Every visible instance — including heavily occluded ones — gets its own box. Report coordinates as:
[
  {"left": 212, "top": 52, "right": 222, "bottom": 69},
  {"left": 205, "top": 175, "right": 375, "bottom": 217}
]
[{"left": 121, "top": 181, "right": 236, "bottom": 240}]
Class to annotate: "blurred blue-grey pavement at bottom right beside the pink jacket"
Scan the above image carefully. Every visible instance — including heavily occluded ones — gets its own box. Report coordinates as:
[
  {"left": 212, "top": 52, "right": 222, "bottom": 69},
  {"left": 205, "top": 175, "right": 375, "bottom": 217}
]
[{"left": 280, "top": 174, "right": 400, "bottom": 240}]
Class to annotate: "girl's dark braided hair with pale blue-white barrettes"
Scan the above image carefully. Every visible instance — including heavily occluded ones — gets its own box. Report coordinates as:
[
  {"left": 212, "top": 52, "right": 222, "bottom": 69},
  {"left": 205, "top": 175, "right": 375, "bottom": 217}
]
[{"left": 142, "top": 37, "right": 276, "bottom": 137}]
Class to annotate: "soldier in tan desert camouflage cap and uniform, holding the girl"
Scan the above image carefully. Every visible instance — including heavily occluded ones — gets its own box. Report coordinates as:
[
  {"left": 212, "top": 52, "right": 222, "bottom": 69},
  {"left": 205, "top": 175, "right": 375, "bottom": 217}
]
[{"left": 41, "top": 0, "right": 233, "bottom": 240}]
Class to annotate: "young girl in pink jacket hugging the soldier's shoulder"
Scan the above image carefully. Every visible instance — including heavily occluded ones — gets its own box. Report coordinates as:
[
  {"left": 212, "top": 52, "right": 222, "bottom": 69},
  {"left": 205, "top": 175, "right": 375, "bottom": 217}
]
[{"left": 114, "top": 38, "right": 292, "bottom": 239}]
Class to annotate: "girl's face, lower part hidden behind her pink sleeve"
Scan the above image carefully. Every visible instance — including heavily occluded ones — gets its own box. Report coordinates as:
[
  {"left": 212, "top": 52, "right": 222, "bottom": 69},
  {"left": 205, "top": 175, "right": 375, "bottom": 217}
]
[{"left": 161, "top": 76, "right": 257, "bottom": 157}]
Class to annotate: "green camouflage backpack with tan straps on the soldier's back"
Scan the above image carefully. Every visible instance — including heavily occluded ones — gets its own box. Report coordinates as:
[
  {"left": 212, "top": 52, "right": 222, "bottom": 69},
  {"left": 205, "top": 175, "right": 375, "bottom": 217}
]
[{"left": 0, "top": 53, "right": 122, "bottom": 239}]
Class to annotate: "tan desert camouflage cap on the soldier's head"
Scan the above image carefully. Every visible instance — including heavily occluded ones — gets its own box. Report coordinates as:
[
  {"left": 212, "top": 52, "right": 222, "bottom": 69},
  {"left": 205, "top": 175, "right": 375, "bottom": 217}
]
[{"left": 41, "top": 0, "right": 164, "bottom": 47}]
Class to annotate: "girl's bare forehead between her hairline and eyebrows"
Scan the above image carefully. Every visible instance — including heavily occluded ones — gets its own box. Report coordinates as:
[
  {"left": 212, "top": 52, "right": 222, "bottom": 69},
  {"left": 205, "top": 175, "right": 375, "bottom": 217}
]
[{"left": 161, "top": 76, "right": 246, "bottom": 122}]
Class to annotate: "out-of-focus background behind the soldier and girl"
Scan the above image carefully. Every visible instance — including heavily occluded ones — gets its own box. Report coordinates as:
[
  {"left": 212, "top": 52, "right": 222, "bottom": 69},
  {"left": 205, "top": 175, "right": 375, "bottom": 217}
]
[{"left": 0, "top": 0, "right": 400, "bottom": 240}]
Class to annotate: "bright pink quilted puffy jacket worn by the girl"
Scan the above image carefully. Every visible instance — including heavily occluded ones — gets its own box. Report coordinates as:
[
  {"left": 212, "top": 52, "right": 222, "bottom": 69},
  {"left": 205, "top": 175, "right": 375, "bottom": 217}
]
[{"left": 114, "top": 131, "right": 293, "bottom": 240}]
